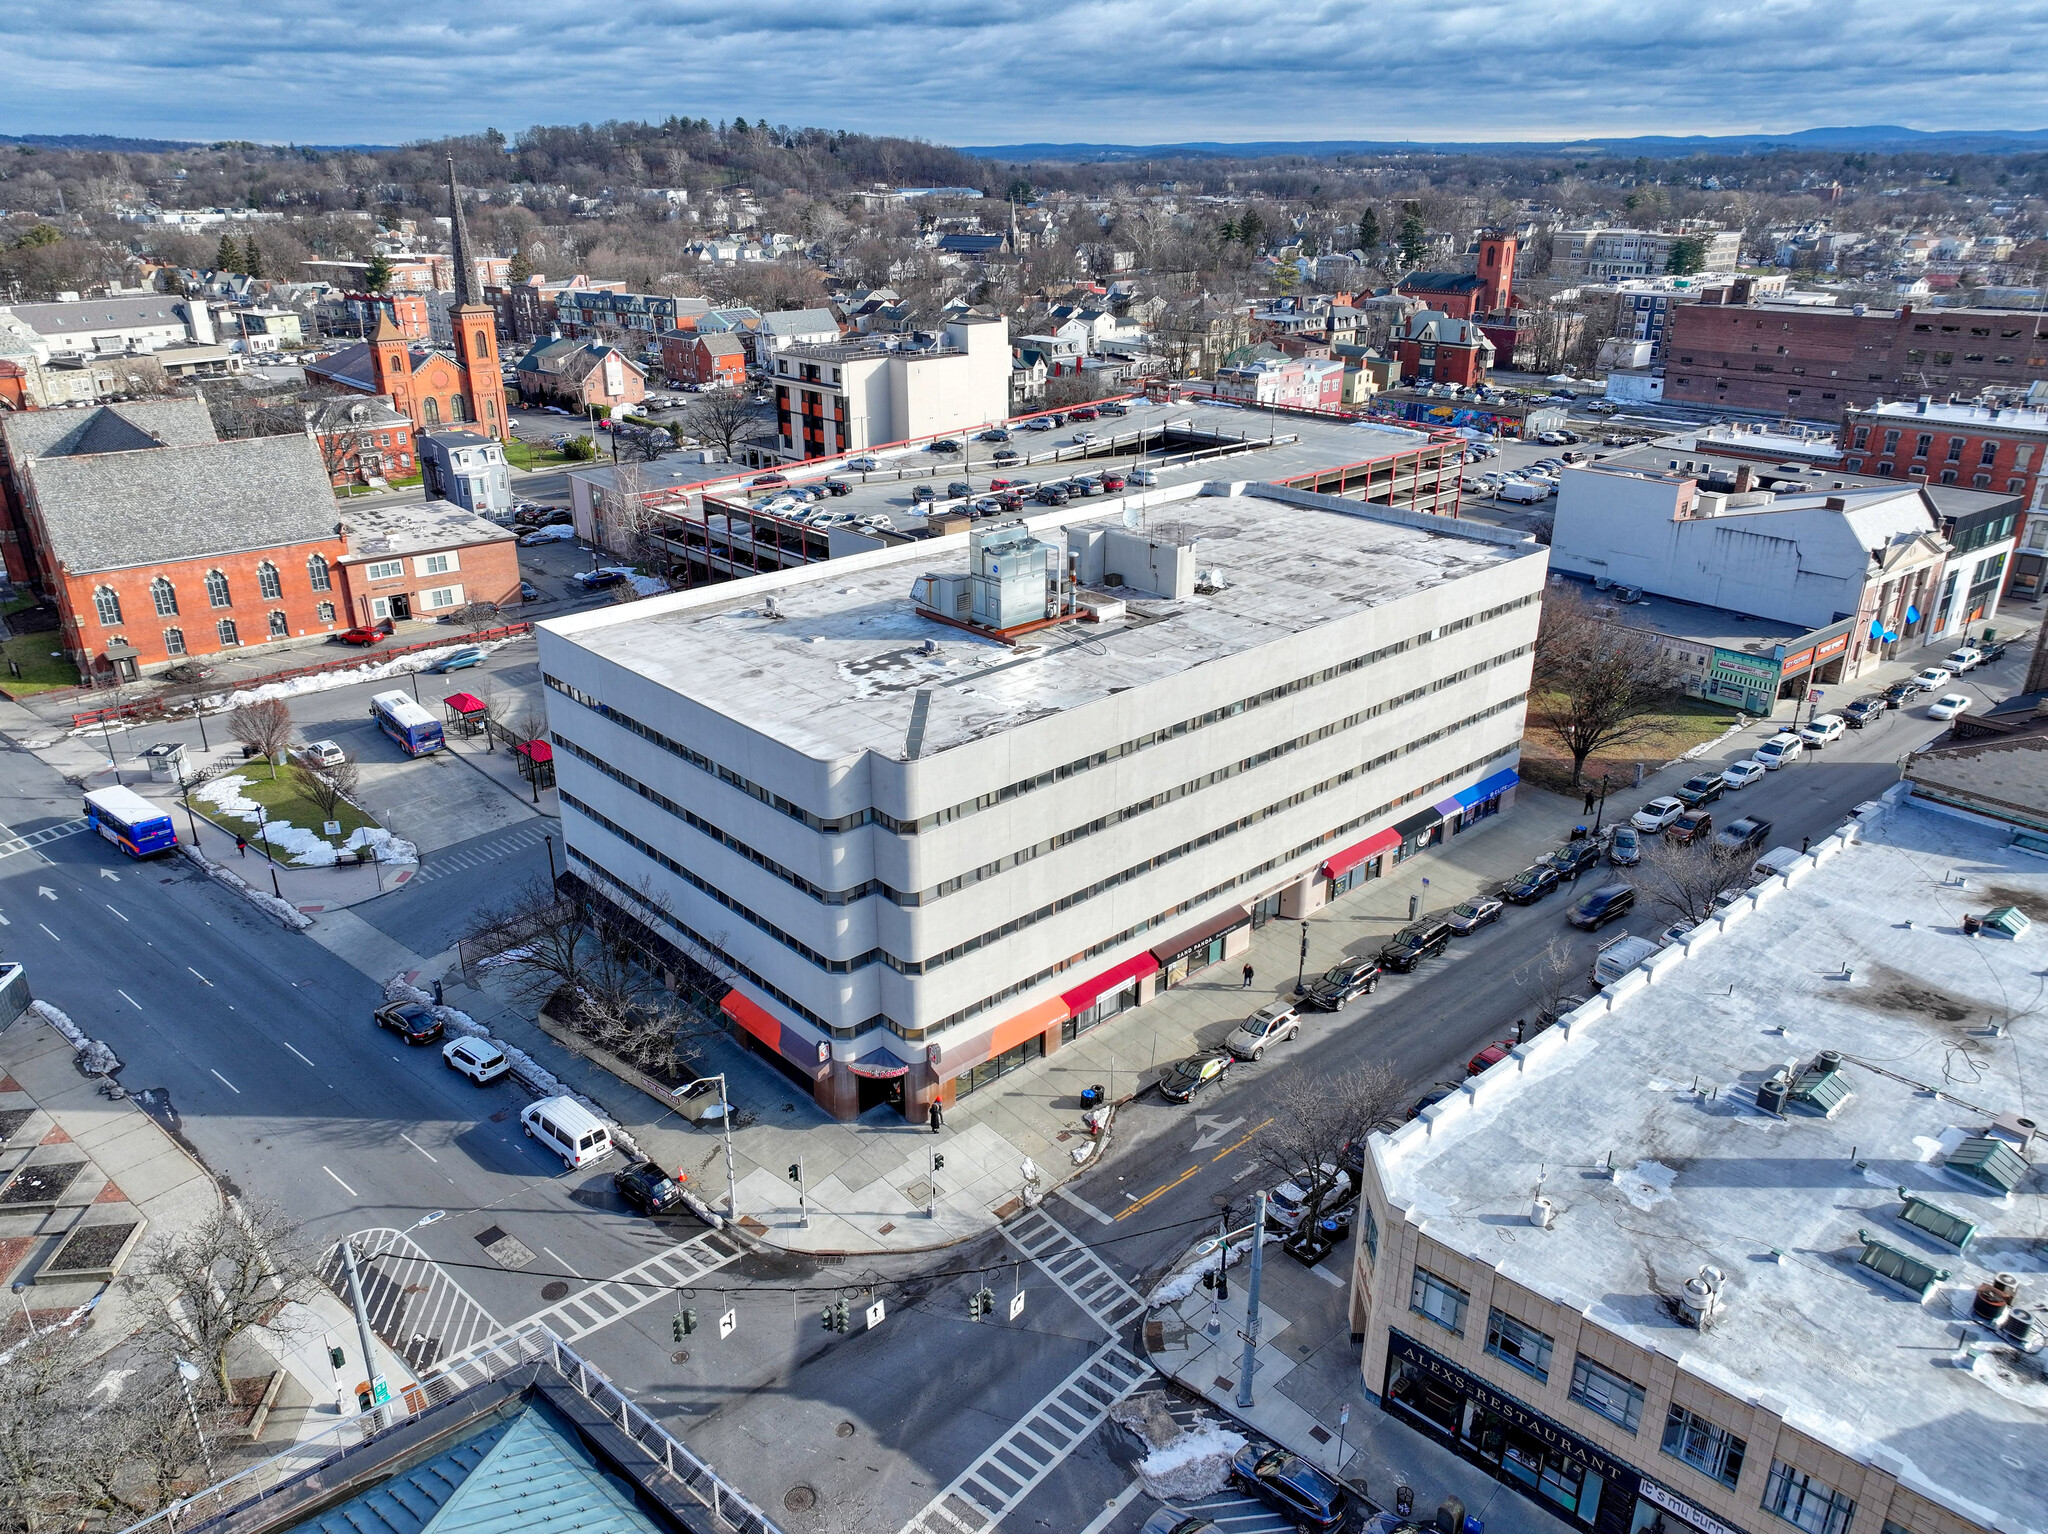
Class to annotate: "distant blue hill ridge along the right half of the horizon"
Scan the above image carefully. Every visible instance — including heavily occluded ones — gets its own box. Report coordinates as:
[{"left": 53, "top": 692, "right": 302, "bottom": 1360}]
[{"left": 961, "top": 125, "right": 2048, "bottom": 162}]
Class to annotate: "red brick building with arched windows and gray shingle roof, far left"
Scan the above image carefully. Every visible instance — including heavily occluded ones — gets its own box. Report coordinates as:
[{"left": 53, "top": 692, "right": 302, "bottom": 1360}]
[{"left": 0, "top": 399, "right": 346, "bottom": 674}]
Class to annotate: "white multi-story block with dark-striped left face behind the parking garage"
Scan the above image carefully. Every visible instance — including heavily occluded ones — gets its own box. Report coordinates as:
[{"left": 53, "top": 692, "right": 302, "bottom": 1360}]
[{"left": 770, "top": 317, "right": 1010, "bottom": 459}]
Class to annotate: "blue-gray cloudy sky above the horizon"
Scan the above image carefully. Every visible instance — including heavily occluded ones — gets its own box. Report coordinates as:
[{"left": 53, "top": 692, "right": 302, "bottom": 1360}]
[{"left": 0, "top": 0, "right": 2048, "bottom": 143}]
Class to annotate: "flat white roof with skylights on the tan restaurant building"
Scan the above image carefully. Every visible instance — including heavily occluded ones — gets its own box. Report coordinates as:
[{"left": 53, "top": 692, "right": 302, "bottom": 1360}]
[{"left": 1374, "top": 791, "right": 2048, "bottom": 1532}]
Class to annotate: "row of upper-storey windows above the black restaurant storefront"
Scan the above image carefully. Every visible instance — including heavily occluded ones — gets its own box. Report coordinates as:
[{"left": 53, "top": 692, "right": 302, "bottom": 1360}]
[{"left": 1409, "top": 1266, "right": 1855, "bottom": 1534}]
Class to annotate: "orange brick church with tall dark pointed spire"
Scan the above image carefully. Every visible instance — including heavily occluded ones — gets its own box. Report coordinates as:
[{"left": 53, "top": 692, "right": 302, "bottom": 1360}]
[{"left": 305, "top": 156, "right": 506, "bottom": 438}]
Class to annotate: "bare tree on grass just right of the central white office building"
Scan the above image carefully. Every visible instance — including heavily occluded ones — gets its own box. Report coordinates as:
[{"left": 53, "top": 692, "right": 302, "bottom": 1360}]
[{"left": 1530, "top": 588, "right": 1679, "bottom": 786}]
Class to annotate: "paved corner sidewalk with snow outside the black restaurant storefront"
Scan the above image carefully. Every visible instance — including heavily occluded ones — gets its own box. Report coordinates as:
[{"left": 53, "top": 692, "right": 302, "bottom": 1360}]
[{"left": 1143, "top": 1241, "right": 1565, "bottom": 1534}]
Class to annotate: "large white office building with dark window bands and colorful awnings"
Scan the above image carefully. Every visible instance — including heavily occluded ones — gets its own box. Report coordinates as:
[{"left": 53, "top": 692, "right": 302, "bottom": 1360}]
[{"left": 541, "top": 473, "right": 1546, "bottom": 1118}]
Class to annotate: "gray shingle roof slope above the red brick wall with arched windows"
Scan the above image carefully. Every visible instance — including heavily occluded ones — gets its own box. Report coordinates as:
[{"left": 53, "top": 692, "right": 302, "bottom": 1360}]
[{"left": 25, "top": 432, "right": 336, "bottom": 576}]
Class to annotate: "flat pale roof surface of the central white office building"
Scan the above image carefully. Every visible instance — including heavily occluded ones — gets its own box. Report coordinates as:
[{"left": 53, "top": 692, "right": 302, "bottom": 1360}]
[{"left": 543, "top": 481, "right": 1542, "bottom": 762}]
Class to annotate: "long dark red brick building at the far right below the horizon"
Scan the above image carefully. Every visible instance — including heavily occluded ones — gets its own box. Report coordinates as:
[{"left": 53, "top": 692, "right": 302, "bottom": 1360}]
[{"left": 1665, "top": 303, "right": 2048, "bottom": 420}]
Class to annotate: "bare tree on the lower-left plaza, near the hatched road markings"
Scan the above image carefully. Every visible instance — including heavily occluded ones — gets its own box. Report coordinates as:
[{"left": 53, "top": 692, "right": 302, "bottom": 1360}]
[{"left": 135, "top": 1202, "right": 319, "bottom": 1401}]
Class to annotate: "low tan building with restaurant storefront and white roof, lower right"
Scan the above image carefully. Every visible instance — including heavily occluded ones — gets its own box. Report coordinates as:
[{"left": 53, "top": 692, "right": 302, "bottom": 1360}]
[{"left": 1352, "top": 794, "right": 2048, "bottom": 1534}]
